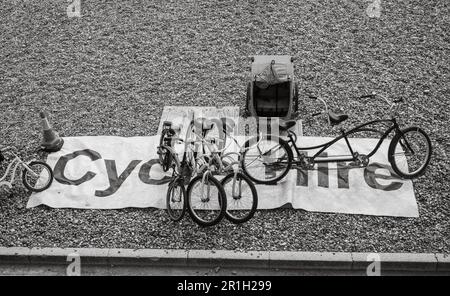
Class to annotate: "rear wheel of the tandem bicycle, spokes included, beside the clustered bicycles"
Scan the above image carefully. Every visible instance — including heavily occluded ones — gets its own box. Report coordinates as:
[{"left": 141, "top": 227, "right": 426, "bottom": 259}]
[{"left": 242, "top": 136, "right": 293, "bottom": 184}]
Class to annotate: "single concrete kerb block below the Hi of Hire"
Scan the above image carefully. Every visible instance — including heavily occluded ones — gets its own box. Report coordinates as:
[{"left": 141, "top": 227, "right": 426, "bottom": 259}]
[{"left": 269, "top": 251, "right": 352, "bottom": 270}]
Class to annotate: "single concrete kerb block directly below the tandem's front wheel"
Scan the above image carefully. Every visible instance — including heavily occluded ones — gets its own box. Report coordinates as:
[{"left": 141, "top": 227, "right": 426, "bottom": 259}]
[{"left": 352, "top": 253, "right": 437, "bottom": 271}]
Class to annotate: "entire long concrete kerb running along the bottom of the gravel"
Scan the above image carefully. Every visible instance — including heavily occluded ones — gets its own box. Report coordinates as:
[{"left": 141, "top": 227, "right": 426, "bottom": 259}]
[{"left": 0, "top": 247, "right": 450, "bottom": 273}]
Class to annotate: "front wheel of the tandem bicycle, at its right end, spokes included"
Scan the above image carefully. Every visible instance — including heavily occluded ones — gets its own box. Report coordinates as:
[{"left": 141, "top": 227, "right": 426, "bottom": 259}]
[{"left": 388, "top": 127, "right": 432, "bottom": 179}]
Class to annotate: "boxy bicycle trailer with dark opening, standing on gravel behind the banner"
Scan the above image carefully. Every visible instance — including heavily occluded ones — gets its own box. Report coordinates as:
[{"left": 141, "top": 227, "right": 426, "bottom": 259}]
[{"left": 246, "top": 55, "right": 298, "bottom": 119}]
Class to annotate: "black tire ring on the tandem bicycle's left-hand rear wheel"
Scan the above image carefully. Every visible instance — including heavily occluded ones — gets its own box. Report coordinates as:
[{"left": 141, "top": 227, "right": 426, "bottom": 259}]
[{"left": 241, "top": 135, "right": 294, "bottom": 184}]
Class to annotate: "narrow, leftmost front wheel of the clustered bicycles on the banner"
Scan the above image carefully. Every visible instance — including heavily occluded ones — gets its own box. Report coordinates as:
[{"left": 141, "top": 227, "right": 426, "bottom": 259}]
[{"left": 166, "top": 179, "right": 186, "bottom": 221}]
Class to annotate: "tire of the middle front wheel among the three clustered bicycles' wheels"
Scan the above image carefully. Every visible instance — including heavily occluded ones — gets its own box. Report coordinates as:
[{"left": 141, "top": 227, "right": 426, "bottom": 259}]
[{"left": 187, "top": 174, "right": 227, "bottom": 226}]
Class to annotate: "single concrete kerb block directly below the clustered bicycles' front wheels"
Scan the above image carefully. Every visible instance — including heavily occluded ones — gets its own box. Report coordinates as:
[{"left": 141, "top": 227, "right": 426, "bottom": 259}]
[{"left": 188, "top": 250, "right": 269, "bottom": 268}]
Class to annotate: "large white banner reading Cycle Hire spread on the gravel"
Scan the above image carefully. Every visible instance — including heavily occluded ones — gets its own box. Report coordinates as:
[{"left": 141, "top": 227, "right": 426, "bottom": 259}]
[{"left": 27, "top": 136, "right": 418, "bottom": 217}]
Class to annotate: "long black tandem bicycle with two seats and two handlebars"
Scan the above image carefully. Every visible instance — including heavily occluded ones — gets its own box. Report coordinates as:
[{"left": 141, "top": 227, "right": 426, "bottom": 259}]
[{"left": 242, "top": 94, "right": 432, "bottom": 184}]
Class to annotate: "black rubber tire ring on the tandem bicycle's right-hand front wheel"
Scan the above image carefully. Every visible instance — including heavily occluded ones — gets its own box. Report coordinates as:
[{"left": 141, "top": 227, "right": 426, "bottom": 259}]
[{"left": 388, "top": 126, "right": 432, "bottom": 179}]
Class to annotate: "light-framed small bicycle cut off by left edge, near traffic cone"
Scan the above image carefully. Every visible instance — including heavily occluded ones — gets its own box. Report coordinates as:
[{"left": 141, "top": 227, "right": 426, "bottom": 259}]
[{"left": 0, "top": 147, "right": 53, "bottom": 192}]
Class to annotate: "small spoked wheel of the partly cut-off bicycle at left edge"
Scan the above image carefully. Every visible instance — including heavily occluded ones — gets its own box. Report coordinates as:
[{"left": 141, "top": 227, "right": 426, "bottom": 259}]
[{"left": 22, "top": 161, "right": 53, "bottom": 192}]
